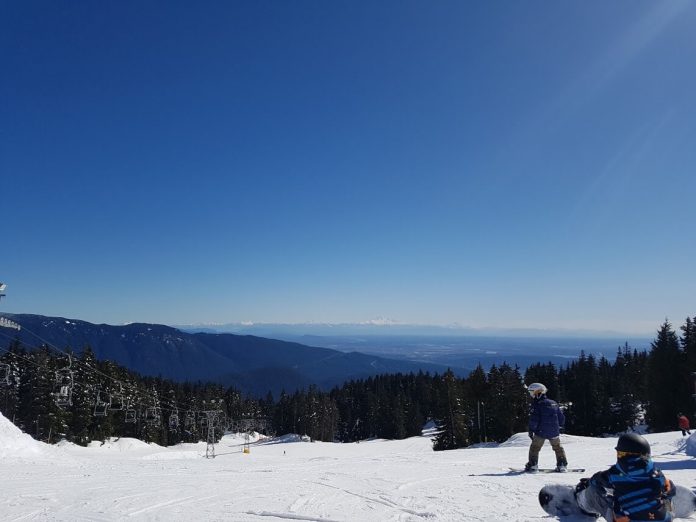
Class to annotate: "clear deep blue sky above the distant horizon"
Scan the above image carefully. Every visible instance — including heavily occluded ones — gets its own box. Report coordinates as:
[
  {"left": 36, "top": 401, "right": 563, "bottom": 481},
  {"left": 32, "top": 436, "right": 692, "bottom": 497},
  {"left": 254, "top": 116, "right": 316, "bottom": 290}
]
[{"left": 0, "top": 0, "right": 696, "bottom": 333}]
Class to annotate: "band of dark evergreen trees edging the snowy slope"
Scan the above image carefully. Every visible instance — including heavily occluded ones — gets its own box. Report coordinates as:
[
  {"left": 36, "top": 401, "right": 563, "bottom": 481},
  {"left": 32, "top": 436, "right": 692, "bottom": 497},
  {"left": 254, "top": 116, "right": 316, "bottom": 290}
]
[{"left": 0, "top": 317, "right": 696, "bottom": 450}]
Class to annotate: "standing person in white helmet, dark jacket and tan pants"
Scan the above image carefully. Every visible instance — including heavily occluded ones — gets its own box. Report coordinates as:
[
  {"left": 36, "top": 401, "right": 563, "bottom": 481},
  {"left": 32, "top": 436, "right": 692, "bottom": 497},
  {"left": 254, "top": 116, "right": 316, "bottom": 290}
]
[{"left": 524, "top": 382, "right": 568, "bottom": 473}]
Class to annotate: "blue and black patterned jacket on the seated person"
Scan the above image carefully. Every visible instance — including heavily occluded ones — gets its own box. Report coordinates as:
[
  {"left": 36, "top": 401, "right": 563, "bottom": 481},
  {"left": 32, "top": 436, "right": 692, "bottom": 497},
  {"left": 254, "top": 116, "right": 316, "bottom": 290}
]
[{"left": 592, "top": 455, "right": 675, "bottom": 522}]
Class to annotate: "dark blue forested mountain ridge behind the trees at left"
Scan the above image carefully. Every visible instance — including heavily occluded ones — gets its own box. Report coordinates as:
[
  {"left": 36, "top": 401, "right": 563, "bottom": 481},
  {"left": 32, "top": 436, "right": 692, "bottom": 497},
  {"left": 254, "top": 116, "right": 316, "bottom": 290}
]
[{"left": 3, "top": 314, "right": 446, "bottom": 396}]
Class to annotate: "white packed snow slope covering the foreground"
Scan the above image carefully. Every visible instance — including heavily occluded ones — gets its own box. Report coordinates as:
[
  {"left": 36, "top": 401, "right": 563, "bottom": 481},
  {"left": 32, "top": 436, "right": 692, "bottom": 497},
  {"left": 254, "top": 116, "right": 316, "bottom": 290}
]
[{"left": 0, "top": 410, "right": 696, "bottom": 522}]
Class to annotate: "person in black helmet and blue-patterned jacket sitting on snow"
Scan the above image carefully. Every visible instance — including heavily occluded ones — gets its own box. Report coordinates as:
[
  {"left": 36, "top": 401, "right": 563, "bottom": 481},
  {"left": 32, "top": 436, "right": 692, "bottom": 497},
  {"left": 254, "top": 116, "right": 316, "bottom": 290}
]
[{"left": 590, "top": 433, "right": 676, "bottom": 522}]
